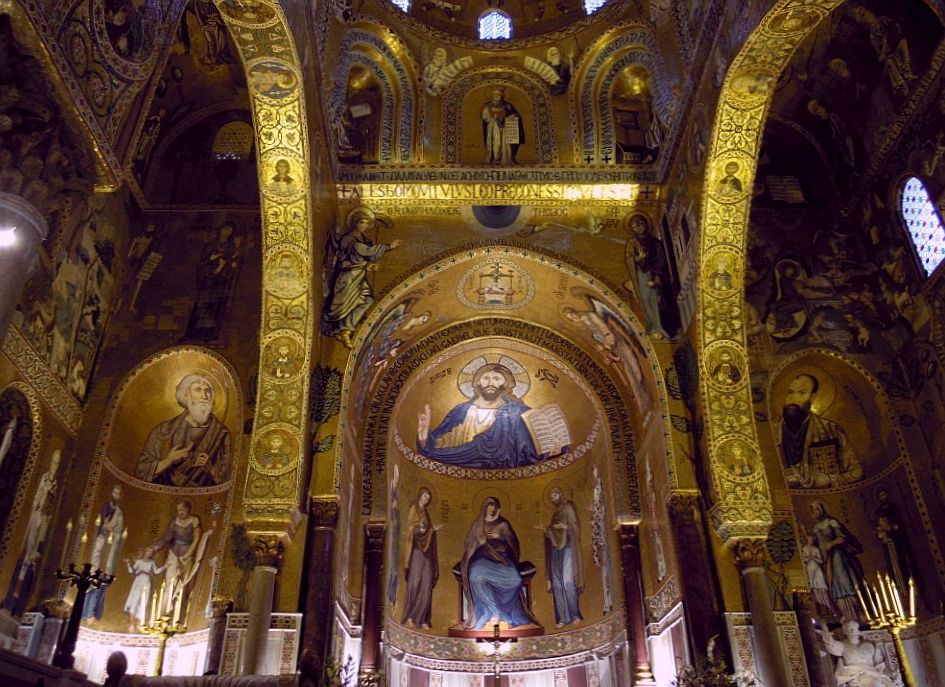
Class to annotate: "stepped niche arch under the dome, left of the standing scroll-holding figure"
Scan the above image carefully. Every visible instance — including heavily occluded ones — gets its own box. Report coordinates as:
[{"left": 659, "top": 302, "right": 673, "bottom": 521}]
[{"left": 325, "top": 24, "right": 422, "bottom": 164}]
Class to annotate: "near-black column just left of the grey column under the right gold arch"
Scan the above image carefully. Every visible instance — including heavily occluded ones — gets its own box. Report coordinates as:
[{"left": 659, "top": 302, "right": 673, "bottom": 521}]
[{"left": 669, "top": 494, "right": 728, "bottom": 665}]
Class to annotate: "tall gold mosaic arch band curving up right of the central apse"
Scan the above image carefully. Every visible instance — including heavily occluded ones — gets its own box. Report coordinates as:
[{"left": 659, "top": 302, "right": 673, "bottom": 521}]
[{"left": 696, "top": 0, "right": 842, "bottom": 544}]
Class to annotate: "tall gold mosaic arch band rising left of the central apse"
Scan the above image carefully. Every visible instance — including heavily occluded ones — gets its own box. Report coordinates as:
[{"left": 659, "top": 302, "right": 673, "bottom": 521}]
[{"left": 214, "top": 0, "right": 317, "bottom": 534}]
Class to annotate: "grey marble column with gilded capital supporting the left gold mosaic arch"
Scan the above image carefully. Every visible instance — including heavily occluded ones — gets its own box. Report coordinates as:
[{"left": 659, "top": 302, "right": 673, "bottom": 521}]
[{"left": 240, "top": 537, "right": 283, "bottom": 675}]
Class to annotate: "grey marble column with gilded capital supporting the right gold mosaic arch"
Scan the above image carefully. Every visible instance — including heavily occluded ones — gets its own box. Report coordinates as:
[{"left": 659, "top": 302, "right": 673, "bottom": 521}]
[{"left": 732, "top": 539, "right": 793, "bottom": 687}]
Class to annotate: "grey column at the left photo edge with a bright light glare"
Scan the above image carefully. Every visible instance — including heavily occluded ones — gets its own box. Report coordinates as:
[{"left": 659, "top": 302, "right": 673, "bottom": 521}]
[{"left": 0, "top": 192, "right": 47, "bottom": 342}]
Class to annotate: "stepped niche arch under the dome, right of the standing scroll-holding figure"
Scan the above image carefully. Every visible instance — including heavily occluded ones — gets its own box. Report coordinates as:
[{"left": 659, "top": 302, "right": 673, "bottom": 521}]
[{"left": 570, "top": 23, "right": 674, "bottom": 164}]
